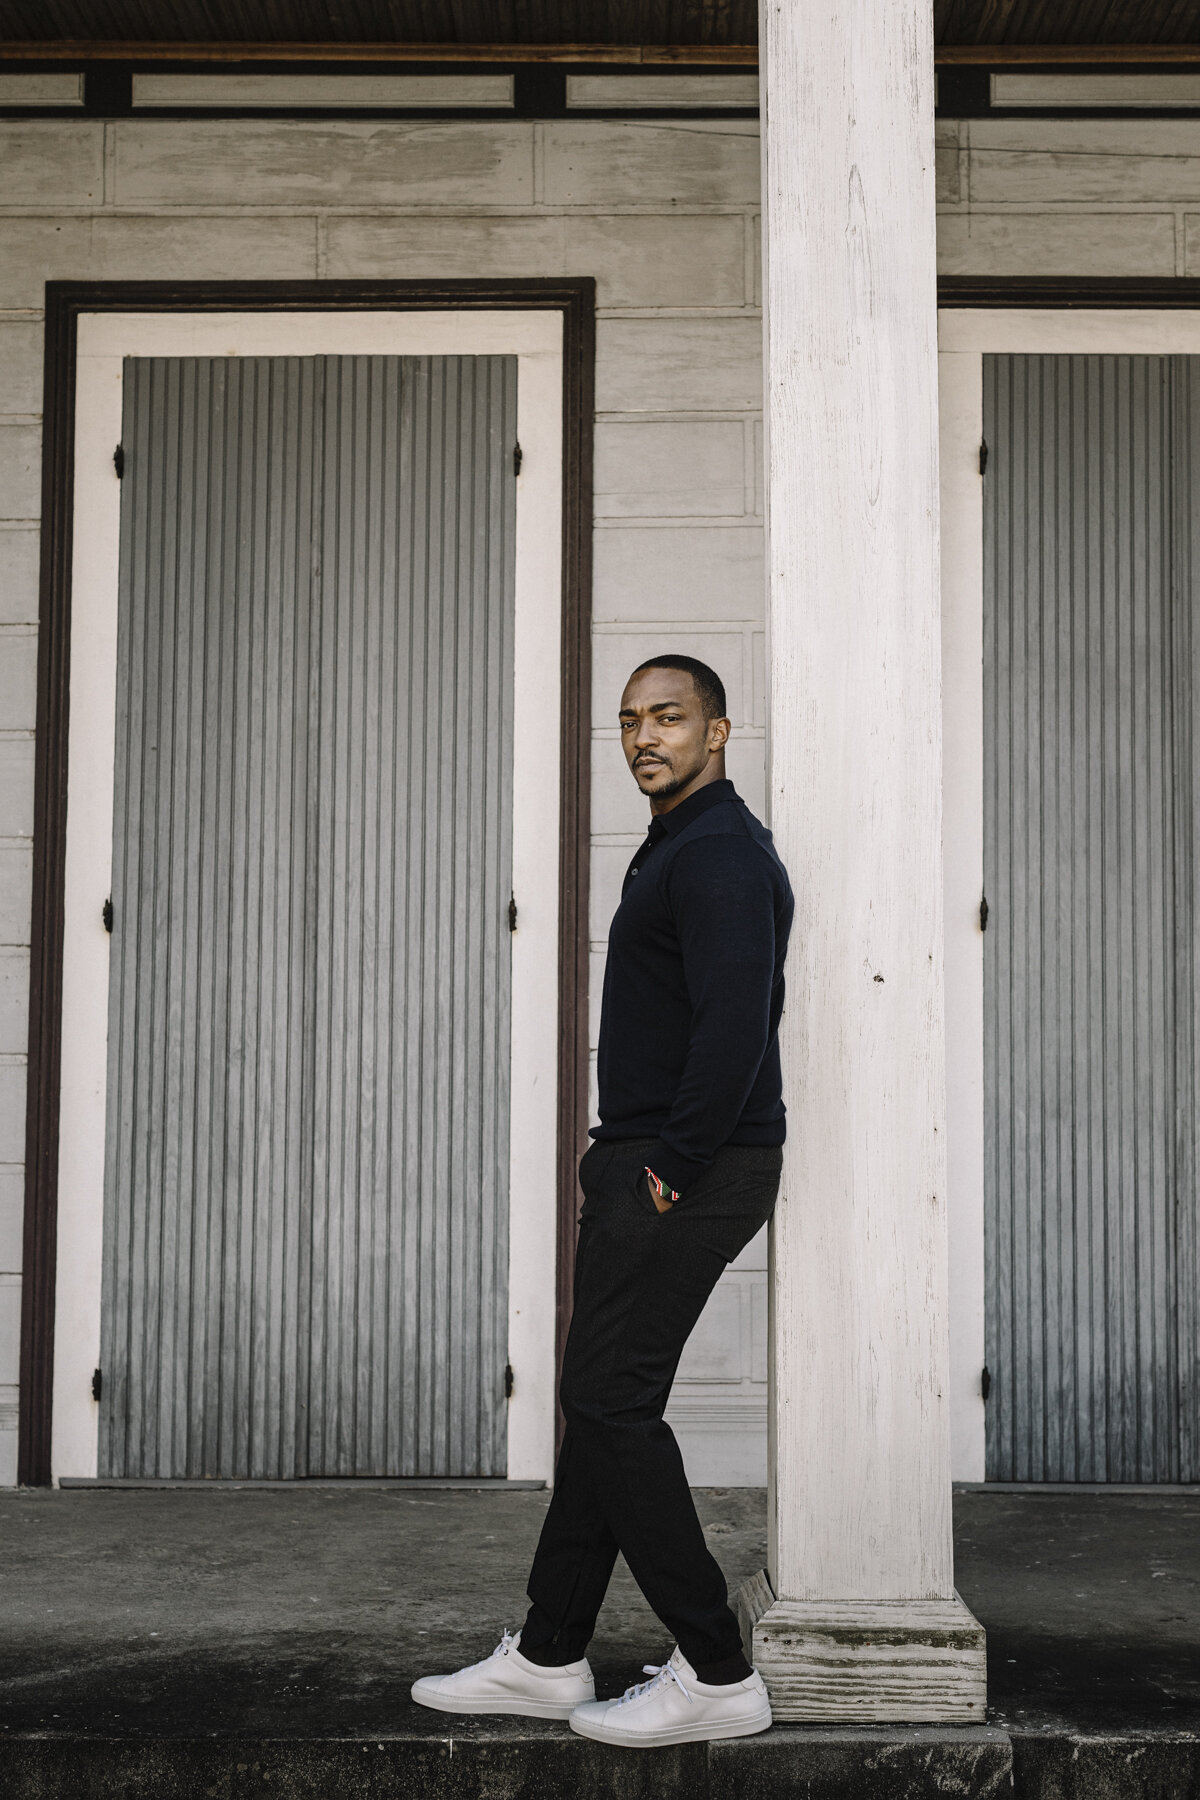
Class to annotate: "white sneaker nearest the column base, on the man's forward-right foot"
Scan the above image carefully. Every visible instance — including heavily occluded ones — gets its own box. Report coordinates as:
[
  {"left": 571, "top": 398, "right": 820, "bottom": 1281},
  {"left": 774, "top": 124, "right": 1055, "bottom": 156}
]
[{"left": 570, "top": 1651, "right": 770, "bottom": 1750}]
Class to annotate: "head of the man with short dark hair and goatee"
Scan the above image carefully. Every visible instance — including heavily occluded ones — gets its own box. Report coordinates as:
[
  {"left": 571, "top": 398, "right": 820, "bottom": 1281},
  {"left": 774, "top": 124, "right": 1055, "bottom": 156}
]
[{"left": 621, "top": 655, "right": 730, "bottom": 812}]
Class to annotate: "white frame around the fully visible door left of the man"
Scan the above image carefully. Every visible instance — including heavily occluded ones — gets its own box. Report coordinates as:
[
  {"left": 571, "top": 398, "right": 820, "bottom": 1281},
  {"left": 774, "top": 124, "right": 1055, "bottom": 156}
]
[{"left": 50, "top": 310, "right": 563, "bottom": 1481}]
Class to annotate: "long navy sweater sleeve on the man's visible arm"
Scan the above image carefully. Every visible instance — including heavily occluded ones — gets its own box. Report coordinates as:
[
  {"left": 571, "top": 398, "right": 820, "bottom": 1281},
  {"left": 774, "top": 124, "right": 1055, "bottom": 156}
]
[{"left": 649, "top": 835, "right": 775, "bottom": 1193}]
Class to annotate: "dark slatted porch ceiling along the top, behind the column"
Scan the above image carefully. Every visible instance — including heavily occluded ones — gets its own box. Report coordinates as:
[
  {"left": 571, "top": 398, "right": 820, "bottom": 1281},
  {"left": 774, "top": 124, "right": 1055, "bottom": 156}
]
[{"left": 0, "top": 0, "right": 1200, "bottom": 59}]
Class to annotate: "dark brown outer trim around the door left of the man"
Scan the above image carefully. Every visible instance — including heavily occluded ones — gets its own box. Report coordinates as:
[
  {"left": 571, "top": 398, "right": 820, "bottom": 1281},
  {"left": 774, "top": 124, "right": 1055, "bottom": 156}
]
[{"left": 18, "top": 279, "right": 596, "bottom": 1487}]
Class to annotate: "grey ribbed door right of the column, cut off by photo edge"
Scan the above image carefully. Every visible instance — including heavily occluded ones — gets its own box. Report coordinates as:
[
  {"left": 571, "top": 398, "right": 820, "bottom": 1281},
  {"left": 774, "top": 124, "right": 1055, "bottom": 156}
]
[{"left": 984, "top": 356, "right": 1200, "bottom": 1481}]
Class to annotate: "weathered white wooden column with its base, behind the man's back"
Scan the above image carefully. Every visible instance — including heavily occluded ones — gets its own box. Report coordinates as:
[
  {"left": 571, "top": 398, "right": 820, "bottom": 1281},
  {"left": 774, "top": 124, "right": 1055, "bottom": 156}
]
[{"left": 754, "top": 0, "right": 984, "bottom": 1721}]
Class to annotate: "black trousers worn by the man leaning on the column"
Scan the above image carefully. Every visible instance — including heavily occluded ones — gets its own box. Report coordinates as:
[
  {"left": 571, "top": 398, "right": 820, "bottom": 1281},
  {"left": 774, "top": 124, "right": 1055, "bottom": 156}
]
[{"left": 522, "top": 1139, "right": 783, "bottom": 1667}]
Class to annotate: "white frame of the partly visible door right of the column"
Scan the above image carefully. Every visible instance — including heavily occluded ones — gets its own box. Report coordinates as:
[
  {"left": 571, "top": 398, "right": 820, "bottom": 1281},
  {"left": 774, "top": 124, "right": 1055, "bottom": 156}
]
[{"left": 937, "top": 306, "right": 1200, "bottom": 1481}]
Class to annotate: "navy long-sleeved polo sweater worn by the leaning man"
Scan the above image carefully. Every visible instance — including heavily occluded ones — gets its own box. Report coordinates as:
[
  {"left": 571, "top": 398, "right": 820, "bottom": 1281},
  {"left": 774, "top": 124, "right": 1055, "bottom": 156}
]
[{"left": 592, "top": 781, "right": 793, "bottom": 1193}]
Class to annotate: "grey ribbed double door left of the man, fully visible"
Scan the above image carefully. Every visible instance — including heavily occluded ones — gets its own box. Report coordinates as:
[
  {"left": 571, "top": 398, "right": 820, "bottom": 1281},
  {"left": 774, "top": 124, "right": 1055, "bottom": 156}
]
[{"left": 101, "top": 356, "right": 516, "bottom": 1478}]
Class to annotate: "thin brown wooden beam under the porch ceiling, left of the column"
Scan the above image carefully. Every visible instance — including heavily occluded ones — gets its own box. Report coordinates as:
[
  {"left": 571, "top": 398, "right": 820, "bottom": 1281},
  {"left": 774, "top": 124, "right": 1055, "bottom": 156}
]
[{"left": 0, "top": 38, "right": 757, "bottom": 68}]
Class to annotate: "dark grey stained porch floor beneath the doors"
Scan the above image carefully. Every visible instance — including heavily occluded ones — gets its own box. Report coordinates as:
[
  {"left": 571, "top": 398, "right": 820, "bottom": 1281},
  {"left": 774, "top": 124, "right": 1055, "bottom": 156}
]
[{"left": 0, "top": 1487, "right": 1200, "bottom": 1739}]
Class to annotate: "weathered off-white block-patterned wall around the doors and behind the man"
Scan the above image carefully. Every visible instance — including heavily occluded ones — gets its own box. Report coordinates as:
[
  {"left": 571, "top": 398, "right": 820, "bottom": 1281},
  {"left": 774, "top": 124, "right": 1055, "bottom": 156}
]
[{"left": 0, "top": 119, "right": 1200, "bottom": 1483}]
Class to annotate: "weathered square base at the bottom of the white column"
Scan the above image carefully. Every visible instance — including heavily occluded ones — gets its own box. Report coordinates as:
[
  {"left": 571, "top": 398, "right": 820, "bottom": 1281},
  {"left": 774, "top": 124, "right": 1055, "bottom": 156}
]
[{"left": 734, "top": 1571, "right": 988, "bottom": 1724}]
